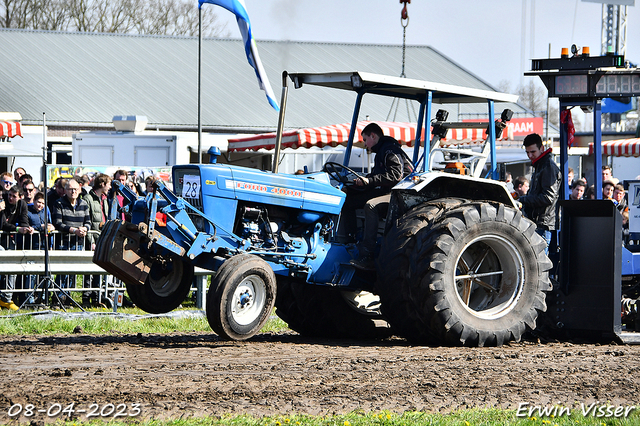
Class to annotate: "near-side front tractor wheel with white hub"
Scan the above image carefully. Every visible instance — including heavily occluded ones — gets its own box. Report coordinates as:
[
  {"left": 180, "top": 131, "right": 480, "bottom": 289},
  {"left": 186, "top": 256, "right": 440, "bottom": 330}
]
[{"left": 207, "top": 254, "right": 276, "bottom": 340}]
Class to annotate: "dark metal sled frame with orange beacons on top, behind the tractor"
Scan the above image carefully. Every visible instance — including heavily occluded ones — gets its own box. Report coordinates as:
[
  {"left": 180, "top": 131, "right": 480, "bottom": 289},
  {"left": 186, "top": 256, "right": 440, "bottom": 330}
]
[{"left": 525, "top": 55, "right": 640, "bottom": 344}]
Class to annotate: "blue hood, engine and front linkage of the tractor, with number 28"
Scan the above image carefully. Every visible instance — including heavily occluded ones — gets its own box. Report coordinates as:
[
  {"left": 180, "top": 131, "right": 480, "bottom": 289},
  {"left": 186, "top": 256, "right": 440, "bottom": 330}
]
[{"left": 138, "top": 164, "right": 356, "bottom": 285}]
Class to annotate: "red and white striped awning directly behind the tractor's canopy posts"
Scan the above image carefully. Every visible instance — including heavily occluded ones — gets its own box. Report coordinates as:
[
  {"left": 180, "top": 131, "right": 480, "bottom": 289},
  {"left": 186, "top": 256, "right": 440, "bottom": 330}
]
[{"left": 229, "top": 121, "right": 507, "bottom": 151}]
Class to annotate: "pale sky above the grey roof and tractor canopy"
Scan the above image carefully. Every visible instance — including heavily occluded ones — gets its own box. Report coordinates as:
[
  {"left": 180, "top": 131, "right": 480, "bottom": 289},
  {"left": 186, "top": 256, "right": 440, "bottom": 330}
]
[{"left": 214, "top": 0, "right": 640, "bottom": 91}]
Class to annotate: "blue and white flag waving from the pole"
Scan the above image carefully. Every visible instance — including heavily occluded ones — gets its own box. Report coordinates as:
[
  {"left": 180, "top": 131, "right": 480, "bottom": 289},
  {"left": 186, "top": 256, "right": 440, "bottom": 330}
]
[{"left": 198, "top": 0, "right": 280, "bottom": 111}]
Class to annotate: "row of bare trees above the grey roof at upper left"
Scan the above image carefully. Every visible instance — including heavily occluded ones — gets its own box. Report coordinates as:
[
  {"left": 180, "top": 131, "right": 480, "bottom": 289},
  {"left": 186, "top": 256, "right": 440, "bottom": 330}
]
[{"left": 0, "top": 0, "right": 228, "bottom": 37}]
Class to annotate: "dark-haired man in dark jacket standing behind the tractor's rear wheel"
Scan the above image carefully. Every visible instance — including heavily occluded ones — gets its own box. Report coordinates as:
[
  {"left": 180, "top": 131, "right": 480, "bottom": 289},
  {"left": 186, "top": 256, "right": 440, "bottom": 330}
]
[{"left": 518, "top": 133, "right": 562, "bottom": 252}]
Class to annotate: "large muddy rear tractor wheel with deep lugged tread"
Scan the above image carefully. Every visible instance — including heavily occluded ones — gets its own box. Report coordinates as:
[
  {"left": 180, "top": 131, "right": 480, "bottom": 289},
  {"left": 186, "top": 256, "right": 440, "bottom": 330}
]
[{"left": 376, "top": 200, "right": 552, "bottom": 346}]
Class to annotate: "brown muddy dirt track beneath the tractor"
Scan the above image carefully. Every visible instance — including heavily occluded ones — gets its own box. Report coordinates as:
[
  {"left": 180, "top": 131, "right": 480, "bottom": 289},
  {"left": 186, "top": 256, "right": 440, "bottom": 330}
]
[{"left": 0, "top": 333, "right": 640, "bottom": 424}]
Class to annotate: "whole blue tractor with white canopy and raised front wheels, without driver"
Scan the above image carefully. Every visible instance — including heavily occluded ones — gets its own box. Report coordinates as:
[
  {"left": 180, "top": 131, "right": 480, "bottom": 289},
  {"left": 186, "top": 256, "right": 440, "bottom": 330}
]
[{"left": 94, "top": 72, "right": 552, "bottom": 346}]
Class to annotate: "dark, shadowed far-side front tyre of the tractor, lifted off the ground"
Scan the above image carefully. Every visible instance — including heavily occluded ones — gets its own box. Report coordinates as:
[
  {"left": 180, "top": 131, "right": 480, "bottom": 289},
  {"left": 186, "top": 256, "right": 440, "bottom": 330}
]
[{"left": 126, "top": 256, "right": 193, "bottom": 314}]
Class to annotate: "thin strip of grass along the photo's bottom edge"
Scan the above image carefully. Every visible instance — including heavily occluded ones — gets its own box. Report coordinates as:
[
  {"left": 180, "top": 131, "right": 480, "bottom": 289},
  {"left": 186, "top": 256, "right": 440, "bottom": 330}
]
[{"left": 12, "top": 408, "right": 640, "bottom": 426}]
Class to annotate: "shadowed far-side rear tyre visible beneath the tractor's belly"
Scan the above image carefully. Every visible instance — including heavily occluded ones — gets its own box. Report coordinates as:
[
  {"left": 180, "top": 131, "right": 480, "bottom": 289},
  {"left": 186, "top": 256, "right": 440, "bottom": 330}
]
[{"left": 276, "top": 277, "right": 392, "bottom": 339}]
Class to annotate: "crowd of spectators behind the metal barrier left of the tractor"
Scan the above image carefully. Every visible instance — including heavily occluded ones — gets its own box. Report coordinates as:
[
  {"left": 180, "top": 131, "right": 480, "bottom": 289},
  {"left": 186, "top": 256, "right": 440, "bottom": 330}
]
[{"left": 0, "top": 167, "right": 155, "bottom": 311}]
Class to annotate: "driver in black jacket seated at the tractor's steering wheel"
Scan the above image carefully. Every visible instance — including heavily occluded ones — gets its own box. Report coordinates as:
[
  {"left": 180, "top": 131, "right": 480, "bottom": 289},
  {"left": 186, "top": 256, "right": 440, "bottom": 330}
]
[{"left": 342, "top": 123, "right": 413, "bottom": 270}]
